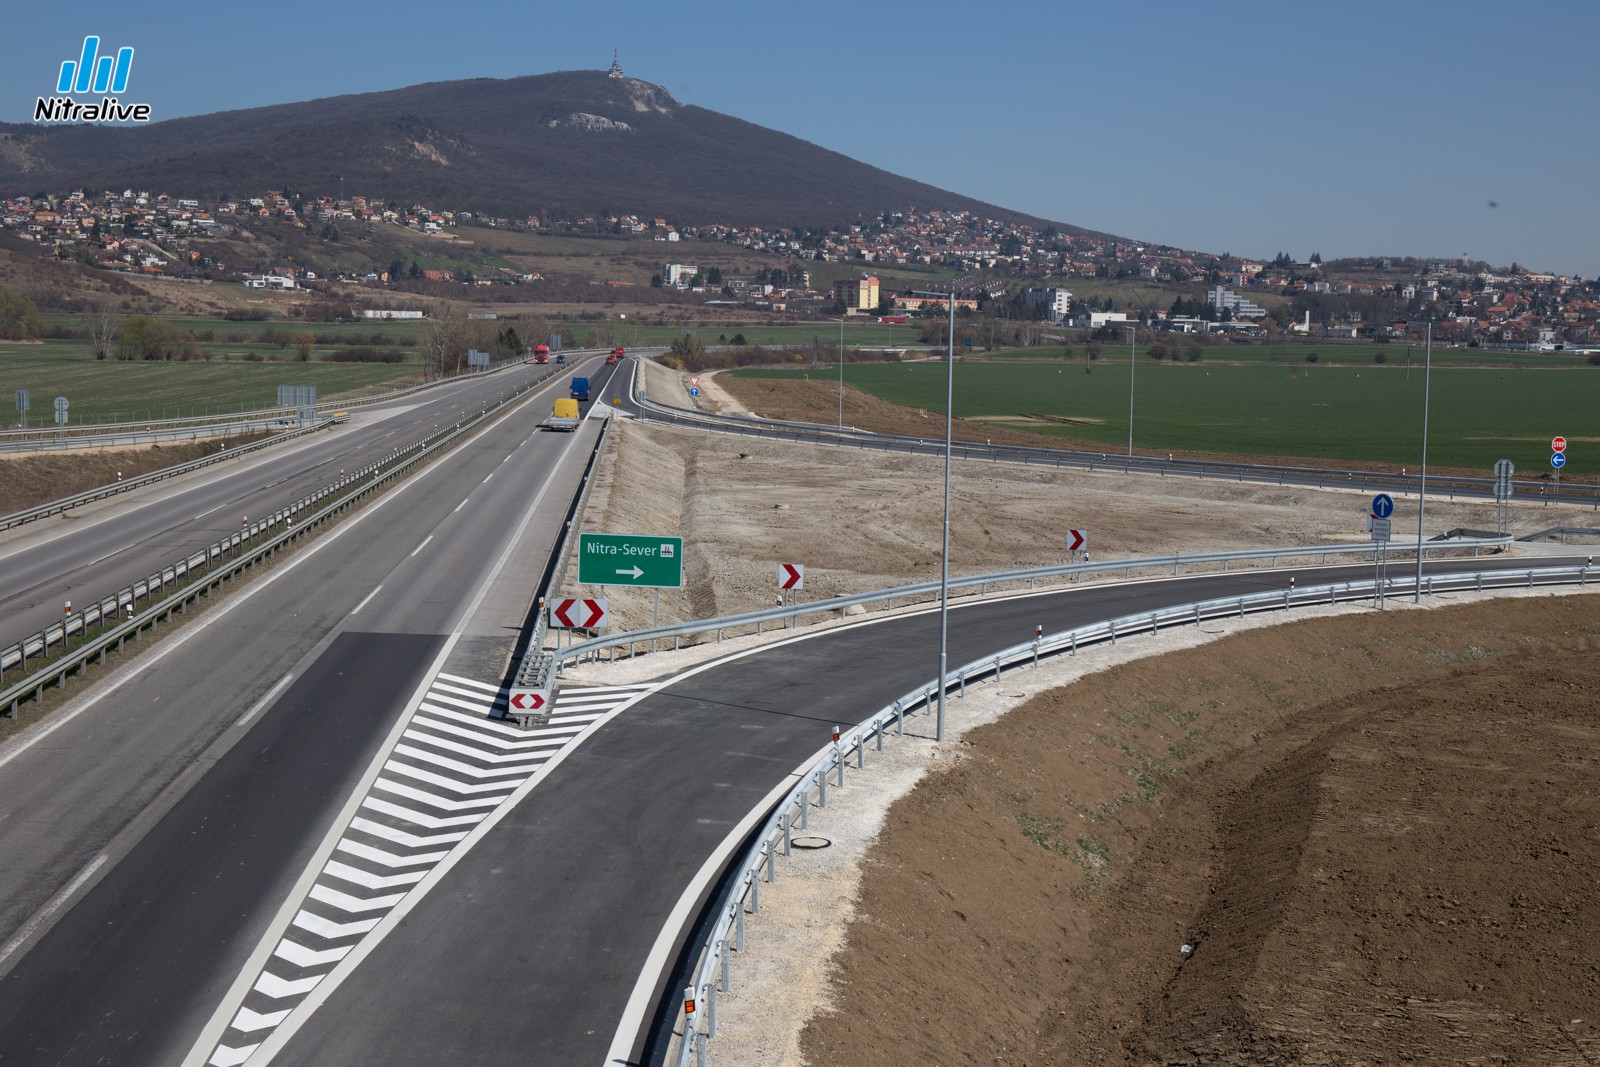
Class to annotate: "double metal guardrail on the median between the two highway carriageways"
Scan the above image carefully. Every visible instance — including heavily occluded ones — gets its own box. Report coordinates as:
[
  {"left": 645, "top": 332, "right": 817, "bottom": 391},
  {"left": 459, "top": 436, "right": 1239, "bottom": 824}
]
[{"left": 0, "top": 367, "right": 563, "bottom": 715}]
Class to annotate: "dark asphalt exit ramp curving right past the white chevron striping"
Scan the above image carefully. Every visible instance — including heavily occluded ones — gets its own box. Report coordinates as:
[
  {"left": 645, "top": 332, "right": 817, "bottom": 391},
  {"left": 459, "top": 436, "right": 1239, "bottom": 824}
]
[{"left": 274, "top": 560, "right": 1580, "bottom": 1067}]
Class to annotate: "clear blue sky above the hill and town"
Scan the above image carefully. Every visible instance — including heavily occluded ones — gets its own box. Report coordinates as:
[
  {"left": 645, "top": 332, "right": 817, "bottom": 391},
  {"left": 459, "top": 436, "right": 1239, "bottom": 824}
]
[{"left": 0, "top": 0, "right": 1600, "bottom": 278}]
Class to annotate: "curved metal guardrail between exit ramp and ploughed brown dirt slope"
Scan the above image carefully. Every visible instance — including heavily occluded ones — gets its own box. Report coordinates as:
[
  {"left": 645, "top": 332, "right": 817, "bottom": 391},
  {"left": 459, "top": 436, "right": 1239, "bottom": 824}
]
[{"left": 667, "top": 566, "right": 1600, "bottom": 1067}]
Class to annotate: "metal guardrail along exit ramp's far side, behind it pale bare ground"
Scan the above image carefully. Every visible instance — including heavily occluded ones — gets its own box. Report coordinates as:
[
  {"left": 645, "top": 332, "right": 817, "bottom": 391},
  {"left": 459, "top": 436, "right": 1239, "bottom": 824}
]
[{"left": 537, "top": 537, "right": 1512, "bottom": 685}]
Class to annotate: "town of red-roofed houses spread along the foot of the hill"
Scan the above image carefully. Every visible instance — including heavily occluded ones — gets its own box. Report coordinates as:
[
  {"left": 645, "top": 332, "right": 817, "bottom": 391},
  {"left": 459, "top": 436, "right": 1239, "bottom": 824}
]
[{"left": 0, "top": 189, "right": 1600, "bottom": 350}]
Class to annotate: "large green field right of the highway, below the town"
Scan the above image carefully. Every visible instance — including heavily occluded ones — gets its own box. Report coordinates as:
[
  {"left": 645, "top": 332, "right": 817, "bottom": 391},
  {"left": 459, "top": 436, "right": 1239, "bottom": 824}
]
[{"left": 738, "top": 355, "right": 1600, "bottom": 477}]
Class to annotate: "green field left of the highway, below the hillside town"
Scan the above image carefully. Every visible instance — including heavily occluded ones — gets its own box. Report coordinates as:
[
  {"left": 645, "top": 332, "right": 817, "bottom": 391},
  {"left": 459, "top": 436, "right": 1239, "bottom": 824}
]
[{"left": 0, "top": 340, "right": 421, "bottom": 426}]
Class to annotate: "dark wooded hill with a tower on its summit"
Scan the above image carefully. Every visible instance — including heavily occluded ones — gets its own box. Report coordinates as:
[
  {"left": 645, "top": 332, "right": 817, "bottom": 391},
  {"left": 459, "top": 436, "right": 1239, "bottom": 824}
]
[{"left": 0, "top": 70, "right": 1085, "bottom": 234}]
